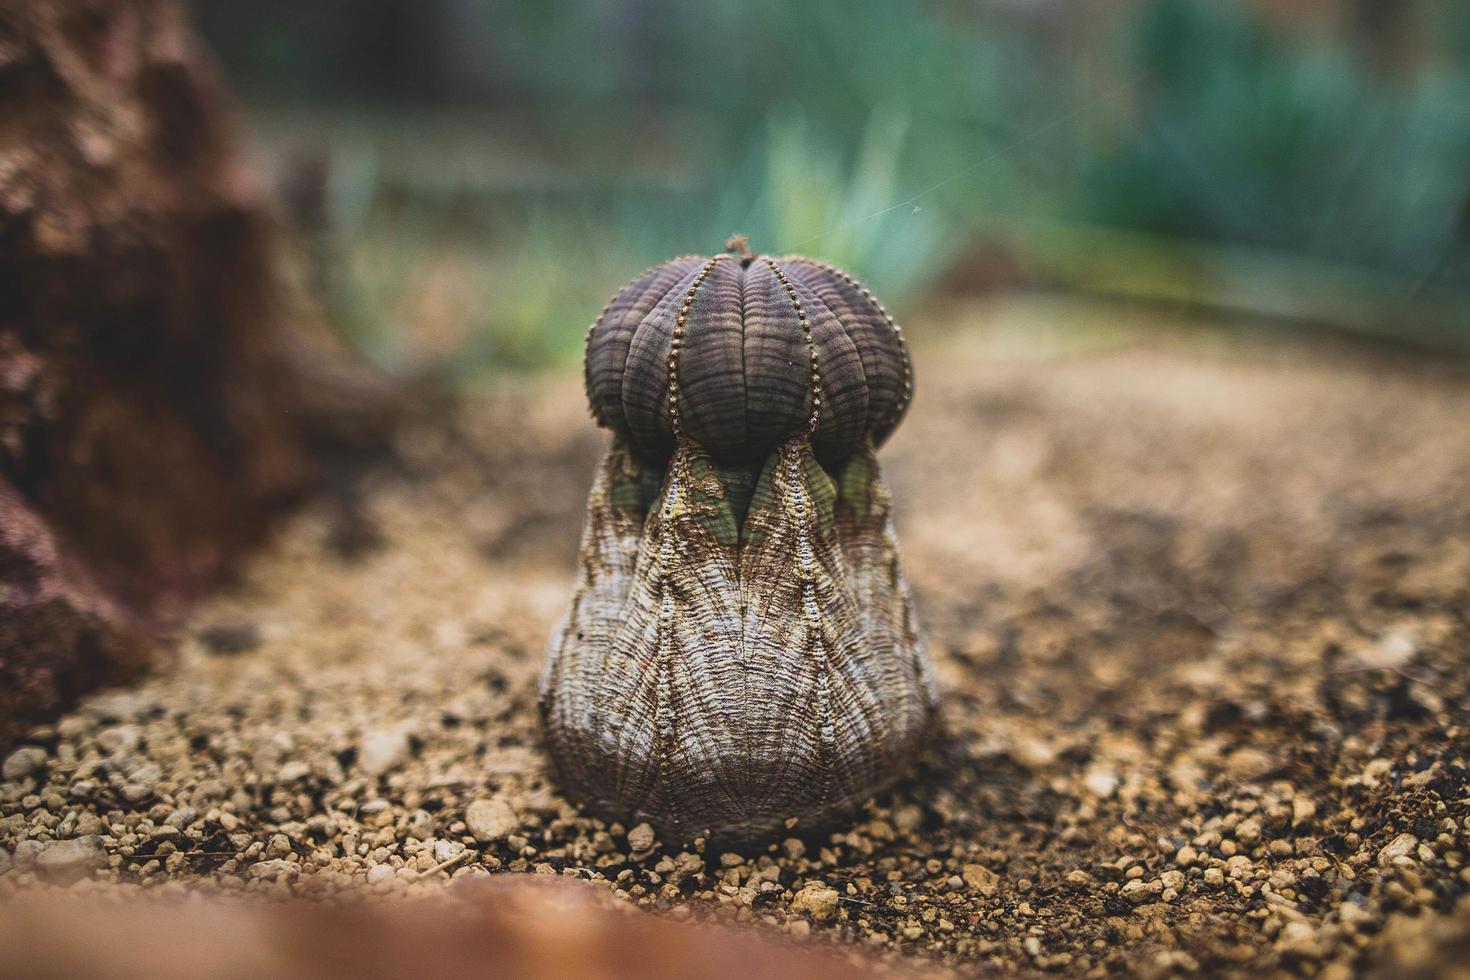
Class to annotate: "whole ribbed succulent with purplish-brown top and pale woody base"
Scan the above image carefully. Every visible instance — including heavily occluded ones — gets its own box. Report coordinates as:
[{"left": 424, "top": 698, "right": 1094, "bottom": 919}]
[{"left": 541, "top": 237, "right": 935, "bottom": 842}]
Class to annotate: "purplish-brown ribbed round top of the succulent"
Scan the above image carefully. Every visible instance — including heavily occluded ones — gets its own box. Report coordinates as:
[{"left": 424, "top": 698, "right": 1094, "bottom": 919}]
[{"left": 587, "top": 237, "right": 913, "bottom": 464}]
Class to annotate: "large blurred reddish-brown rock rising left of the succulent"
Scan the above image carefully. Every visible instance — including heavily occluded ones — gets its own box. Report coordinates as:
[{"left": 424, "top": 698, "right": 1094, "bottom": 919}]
[{"left": 0, "top": 0, "right": 387, "bottom": 745}]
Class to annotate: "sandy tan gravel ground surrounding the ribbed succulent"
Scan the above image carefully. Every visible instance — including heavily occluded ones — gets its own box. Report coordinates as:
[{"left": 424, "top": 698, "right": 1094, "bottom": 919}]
[{"left": 0, "top": 304, "right": 1470, "bottom": 977}]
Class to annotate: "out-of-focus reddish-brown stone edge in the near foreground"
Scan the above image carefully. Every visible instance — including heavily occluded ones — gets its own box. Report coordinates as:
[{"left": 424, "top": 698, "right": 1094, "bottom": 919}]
[{"left": 0, "top": 876, "right": 913, "bottom": 980}]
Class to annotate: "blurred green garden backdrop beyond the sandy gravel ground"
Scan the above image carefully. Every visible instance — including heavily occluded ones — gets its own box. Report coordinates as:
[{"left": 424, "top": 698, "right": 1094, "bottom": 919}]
[{"left": 194, "top": 0, "right": 1470, "bottom": 379}]
